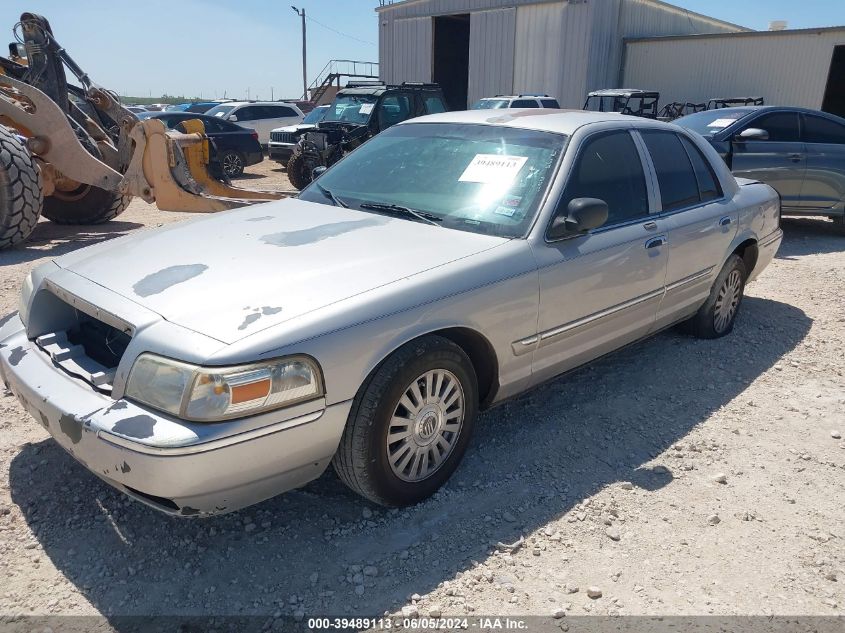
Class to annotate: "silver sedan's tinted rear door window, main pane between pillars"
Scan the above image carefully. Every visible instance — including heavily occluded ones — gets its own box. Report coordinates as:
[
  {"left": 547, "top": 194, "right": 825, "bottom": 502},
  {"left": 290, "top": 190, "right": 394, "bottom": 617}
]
[{"left": 640, "top": 130, "right": 700, "bottom": 211}]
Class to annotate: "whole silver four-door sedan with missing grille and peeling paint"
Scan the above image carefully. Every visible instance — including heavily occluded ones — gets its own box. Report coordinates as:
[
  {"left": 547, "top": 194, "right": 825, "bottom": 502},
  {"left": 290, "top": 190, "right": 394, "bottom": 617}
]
[{"left": 0, "top": 110, "right": 782, "bottom": 516}]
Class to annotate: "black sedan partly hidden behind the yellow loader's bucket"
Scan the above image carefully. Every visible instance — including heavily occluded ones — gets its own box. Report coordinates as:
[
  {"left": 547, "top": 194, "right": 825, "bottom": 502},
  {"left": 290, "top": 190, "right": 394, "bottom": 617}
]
[{"left": 138, "top": 111, "right": 264, "bottom": 178}]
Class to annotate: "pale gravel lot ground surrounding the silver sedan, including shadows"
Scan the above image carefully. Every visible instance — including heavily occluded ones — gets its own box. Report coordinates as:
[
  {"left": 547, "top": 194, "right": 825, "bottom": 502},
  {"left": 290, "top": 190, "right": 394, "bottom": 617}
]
[{"left": 0, "top": 162, "right": 845, "bottom": 628}]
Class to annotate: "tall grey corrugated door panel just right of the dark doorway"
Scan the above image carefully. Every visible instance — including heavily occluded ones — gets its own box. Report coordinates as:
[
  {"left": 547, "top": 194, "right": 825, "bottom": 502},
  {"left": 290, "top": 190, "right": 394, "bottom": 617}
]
[{"left": 468, "top": 8, "right": 516, "bottom": 104}]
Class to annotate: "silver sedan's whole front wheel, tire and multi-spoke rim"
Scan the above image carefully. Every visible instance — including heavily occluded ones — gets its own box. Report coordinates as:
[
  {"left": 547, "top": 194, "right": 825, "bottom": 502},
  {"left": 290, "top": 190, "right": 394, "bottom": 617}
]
[{"left": 332, "top": 336, "right": 478, "bottom": 506}]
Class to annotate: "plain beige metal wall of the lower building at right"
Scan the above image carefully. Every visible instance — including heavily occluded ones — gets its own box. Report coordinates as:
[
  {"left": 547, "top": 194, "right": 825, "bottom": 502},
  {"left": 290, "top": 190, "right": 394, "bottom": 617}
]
[{"left": 624, "top": 29, "right": 845, "bottom": 109}]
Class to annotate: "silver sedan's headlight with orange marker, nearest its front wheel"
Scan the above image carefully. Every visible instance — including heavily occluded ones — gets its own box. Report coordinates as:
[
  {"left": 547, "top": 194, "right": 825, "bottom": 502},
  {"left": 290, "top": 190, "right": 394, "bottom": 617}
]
[{"left": 126, "top": 354, "right": 323, "bottom": 422}]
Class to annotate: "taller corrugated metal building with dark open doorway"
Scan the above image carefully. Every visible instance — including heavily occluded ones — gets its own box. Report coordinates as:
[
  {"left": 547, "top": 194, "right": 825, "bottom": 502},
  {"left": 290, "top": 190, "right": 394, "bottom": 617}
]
[{"left": 377, "top": 0, "right": 744, "bottom": 109}]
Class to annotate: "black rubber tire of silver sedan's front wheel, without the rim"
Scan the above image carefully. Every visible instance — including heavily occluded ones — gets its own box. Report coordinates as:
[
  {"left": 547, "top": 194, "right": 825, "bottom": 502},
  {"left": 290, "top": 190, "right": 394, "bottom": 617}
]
[{"left": 332, "top": 336, "right": 478, "bottom": 506}]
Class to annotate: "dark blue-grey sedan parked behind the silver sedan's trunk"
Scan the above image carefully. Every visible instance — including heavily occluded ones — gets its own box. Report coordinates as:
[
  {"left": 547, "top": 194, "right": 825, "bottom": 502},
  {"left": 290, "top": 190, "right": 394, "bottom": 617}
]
[{"left": 675, "top": 106, "right": 845, "bottom": 235}]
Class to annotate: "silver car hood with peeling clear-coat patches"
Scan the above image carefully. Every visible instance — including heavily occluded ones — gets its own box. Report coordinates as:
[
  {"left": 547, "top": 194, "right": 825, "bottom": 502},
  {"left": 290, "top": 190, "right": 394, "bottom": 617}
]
[{"left": 55, "top": 198, "right": 508, "bottom": 343}]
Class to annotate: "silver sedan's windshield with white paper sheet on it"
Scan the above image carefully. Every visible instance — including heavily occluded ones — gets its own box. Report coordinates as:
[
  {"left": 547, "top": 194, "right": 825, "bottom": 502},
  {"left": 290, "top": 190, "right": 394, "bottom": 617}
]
[{"left": 300, "top": 123, "right": 567, "bottom": 237}]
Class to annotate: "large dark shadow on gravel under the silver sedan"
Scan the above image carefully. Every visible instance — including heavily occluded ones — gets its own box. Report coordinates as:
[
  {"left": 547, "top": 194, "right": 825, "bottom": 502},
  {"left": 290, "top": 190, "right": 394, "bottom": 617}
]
[{"left": 10, "top": 296, "right": 811, "bottom": 630}]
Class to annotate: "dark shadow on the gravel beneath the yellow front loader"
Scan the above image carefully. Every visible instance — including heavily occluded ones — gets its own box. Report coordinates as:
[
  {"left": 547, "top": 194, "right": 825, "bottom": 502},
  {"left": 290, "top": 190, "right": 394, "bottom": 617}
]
[{"left": 0, "top": 220, "right": 143, "bottom": 266}]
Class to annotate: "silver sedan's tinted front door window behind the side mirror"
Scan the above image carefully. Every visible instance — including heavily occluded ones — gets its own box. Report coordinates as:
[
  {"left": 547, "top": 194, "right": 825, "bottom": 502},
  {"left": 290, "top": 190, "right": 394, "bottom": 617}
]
[{"left": 562, "top": 130, "right": 648, "bottom": 226}]
